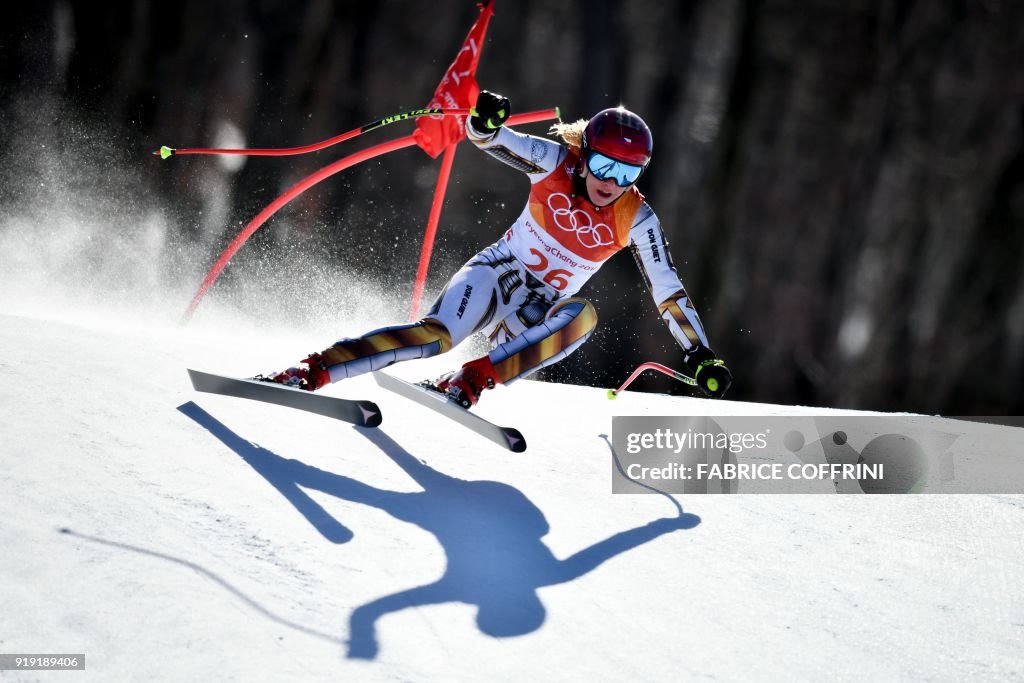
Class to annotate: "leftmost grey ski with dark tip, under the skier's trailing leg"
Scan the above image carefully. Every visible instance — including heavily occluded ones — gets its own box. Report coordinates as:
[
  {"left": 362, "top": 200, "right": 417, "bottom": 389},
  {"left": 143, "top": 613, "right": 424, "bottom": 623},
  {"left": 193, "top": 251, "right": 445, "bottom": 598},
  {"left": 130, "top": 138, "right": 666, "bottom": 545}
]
[{"left": 188, "top": 369, "right": 382, "bottom": 427}]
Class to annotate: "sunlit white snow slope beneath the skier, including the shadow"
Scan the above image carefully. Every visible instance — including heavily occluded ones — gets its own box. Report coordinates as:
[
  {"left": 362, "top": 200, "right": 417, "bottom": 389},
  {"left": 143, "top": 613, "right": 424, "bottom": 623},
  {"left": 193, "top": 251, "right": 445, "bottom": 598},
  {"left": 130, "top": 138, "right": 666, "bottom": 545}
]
[{"left": 0, "top": 306, "right": 1024, "bottom": 681}]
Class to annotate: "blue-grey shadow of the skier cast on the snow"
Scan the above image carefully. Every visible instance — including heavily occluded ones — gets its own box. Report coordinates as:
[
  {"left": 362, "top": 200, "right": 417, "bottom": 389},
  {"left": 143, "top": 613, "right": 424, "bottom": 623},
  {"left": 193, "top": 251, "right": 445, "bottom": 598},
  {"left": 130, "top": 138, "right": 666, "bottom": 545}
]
[{"left": 178, "top": 402, "right": 700, "bottom": 658}]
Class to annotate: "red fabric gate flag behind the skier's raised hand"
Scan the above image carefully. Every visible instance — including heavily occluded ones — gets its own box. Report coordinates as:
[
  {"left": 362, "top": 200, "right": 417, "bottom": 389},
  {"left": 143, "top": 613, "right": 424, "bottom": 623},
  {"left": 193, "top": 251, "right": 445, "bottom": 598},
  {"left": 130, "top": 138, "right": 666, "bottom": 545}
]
[{"left": 413, "top": 0, "right": 495, "bottom": 159}]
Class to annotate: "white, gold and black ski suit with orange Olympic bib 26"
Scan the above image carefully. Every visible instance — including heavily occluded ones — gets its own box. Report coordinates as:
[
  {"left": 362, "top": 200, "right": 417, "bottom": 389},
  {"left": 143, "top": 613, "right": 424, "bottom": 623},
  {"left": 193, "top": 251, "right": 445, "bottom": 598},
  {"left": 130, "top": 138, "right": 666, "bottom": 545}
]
[{"left": 305, "top": 122, "right": 708, "bottom": 383}]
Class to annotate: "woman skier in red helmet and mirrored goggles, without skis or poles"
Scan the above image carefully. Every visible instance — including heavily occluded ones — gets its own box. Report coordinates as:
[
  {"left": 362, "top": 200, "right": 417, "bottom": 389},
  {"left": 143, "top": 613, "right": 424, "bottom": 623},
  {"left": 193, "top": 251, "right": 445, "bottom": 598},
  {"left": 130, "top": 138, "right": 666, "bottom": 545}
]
[{"left": 258, "top": 90, "right": 732, "bottom": 408}]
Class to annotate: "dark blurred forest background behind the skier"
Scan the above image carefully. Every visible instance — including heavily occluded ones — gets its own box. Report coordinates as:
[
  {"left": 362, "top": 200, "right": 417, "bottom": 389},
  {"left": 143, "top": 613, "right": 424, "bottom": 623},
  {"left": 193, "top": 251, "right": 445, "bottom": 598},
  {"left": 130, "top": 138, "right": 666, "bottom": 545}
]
[{"left": 0, "top": 0, "right": 1024, "bottom": 415}]
